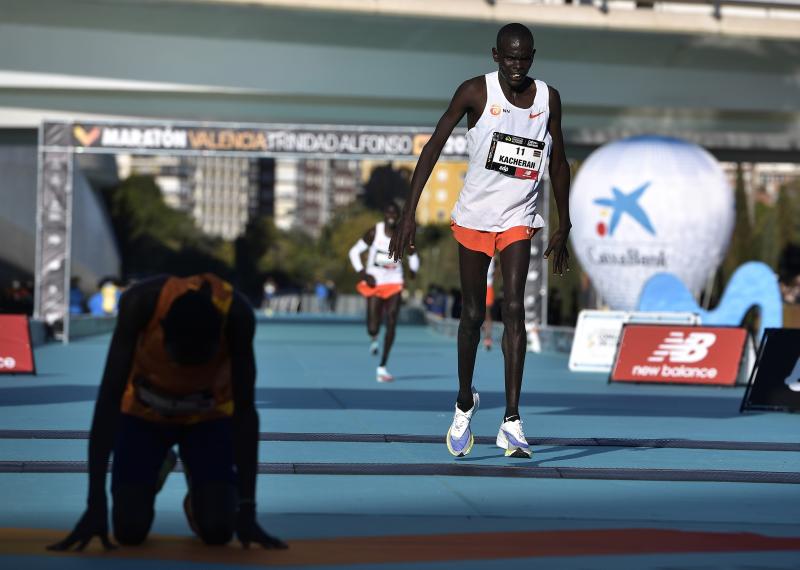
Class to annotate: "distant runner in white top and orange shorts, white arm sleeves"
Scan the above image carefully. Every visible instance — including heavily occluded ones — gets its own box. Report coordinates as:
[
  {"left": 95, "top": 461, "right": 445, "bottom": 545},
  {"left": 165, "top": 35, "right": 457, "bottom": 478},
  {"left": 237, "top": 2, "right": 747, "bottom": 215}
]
[{"left": 349, "top": 202, "right": 419, "bottom": 382}]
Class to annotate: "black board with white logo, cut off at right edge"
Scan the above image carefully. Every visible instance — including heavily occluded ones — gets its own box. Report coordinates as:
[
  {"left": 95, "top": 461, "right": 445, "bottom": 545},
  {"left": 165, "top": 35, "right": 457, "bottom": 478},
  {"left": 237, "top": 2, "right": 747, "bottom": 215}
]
[{"left": 741, "top": 329, "right": 800, "bottom": 412}]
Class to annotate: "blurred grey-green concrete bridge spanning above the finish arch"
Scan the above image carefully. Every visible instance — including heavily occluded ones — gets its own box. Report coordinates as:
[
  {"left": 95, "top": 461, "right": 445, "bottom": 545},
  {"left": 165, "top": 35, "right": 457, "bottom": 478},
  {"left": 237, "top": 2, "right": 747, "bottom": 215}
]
[{"left": 0, "top": 0, "right": 800, "bottom": 160}]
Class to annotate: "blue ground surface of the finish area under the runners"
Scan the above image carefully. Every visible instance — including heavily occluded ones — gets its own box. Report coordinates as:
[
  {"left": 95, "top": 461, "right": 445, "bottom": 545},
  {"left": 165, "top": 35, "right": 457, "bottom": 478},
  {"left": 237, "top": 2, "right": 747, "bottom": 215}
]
[{"left": 0, "top": 319, "right": 800, "bottom": 570}]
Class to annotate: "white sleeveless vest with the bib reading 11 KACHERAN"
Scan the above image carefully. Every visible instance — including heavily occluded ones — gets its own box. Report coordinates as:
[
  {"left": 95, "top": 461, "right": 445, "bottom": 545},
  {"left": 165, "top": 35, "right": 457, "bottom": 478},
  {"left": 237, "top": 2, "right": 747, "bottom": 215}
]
[{"left": 452, "top": 71, "right": 552, "bottom": 232}]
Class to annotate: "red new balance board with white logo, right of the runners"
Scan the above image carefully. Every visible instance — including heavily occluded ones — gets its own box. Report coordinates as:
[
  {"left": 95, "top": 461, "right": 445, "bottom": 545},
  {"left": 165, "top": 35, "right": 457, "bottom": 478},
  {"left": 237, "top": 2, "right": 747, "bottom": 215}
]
[{"left": 609, "top": 324, "right": 747, "bottom": 386}]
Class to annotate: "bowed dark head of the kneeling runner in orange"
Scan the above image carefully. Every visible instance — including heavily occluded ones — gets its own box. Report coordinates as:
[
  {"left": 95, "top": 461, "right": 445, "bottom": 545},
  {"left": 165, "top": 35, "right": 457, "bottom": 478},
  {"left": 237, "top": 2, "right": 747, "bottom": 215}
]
[{"left": 161, "top": 291, "right": 222, "bottom": 366}]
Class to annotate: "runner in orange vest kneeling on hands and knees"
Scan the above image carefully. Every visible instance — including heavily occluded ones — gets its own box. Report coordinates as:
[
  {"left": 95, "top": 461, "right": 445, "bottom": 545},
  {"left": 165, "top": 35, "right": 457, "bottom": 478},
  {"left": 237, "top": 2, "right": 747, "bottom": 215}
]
[{"left": 49, "top": 274, "right": 286, "bottom": 550}]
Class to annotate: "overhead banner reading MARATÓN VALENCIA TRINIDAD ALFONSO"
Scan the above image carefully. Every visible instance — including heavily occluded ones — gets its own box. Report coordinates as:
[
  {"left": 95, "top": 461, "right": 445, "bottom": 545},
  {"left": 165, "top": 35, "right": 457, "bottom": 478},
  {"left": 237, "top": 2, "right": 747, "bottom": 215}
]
[{"left": 44, "top": 122, "right": 467, "bottom": 159}]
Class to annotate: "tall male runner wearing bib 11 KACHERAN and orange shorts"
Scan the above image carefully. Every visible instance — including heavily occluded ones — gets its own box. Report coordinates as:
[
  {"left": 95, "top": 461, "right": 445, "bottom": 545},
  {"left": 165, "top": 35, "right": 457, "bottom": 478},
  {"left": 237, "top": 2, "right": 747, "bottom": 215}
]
[{"left": 389, "top": 24, "right": 571, "bottom": 458}]
